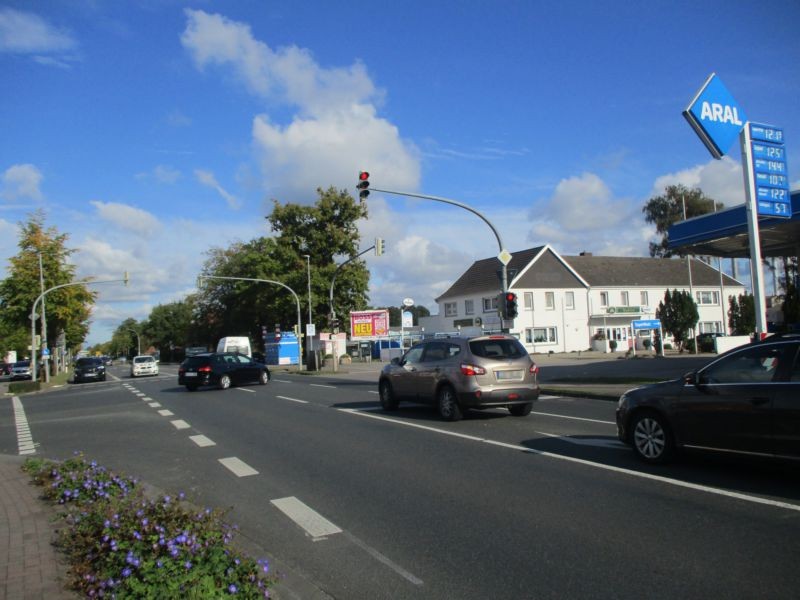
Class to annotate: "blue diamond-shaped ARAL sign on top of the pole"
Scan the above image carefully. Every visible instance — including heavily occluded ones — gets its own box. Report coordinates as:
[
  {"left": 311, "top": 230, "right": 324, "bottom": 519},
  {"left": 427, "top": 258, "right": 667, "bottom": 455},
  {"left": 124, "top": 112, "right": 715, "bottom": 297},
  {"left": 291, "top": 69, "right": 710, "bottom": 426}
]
[{"left": 683, "top": 73, "right": 748, "bottom": 158}]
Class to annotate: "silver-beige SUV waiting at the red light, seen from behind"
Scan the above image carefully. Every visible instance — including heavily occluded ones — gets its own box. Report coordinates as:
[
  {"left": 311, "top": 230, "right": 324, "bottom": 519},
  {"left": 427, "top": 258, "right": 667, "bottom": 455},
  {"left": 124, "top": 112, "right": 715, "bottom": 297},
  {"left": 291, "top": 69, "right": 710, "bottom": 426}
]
[{"left": 378, "top": 334, "right": 539, "bottom": 421}]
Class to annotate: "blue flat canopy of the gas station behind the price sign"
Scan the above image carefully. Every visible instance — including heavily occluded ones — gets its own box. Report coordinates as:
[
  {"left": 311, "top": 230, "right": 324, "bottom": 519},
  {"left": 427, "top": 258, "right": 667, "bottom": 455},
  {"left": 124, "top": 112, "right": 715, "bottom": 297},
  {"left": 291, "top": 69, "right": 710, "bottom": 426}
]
[{"left": 668, "top": 190, "right": 800, "bottom": 258}]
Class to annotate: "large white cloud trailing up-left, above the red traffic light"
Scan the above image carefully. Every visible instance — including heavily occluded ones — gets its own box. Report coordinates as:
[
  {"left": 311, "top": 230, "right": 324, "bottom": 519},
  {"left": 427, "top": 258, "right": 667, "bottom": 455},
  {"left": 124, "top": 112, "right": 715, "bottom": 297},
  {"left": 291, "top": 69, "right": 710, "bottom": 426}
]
[{"left": 181, "top": 10, "right": 420, "bottom": 202}]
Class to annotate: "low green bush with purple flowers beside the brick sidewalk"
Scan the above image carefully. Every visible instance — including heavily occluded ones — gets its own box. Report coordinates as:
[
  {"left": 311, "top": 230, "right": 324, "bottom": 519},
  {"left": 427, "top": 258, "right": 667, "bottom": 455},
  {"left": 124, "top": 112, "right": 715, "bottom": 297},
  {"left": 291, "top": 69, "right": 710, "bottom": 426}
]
[{"left": 23, "top": 454, "right": 274, "bottom": 599}]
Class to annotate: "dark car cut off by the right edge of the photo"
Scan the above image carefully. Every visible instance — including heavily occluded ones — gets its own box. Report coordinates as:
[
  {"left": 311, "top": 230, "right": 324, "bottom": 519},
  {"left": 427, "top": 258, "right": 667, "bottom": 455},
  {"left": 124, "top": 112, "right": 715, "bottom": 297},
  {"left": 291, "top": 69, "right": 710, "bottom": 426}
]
[{"left": 617, "top": 334, "right": 800, "bottom": 463}]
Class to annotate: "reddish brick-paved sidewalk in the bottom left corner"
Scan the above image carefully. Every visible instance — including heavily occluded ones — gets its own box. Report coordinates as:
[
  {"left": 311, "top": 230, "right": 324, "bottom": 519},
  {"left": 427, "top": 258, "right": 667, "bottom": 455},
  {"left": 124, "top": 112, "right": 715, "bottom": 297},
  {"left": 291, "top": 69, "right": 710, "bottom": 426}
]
[{"left": 0, "top": 455, "right": 80, "bottom": 600}]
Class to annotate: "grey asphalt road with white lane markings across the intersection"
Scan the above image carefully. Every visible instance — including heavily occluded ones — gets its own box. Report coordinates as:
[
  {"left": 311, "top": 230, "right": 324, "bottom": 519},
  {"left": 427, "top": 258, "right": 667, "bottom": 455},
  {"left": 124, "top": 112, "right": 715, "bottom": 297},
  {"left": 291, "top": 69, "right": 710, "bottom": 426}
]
[{"left": 0, "top": 361, "right": 800, "bottom": 599}]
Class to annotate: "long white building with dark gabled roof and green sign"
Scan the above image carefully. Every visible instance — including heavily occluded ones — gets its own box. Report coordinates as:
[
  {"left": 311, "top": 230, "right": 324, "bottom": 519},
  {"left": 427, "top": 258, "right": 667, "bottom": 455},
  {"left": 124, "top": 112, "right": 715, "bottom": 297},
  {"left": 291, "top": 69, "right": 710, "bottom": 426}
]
[{"left": 420, "top": 245, "right": 745, "bottom": 352}]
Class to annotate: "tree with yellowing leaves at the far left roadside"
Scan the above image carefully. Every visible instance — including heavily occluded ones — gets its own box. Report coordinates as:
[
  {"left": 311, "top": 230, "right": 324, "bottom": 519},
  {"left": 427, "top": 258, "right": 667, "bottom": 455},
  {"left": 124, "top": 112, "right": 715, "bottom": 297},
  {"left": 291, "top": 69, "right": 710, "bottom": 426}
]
[{"left": 0, "top": 211, "right": 97, "bottom": 353}]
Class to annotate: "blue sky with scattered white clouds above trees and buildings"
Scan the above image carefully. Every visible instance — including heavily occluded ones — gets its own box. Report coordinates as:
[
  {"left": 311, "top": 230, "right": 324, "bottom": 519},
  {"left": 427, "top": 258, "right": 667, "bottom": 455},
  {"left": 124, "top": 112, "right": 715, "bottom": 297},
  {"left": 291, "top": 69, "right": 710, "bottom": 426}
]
[{"left": 0, "top": 0, "right": 800, "bottom": 344}]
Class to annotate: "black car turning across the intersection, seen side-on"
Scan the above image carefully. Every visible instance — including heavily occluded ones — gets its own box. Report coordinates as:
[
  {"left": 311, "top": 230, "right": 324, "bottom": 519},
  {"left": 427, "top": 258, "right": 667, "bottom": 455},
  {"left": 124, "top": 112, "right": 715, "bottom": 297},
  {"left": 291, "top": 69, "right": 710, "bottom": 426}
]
[{"left": 178, "top": 352, "right": 270, "bottom": 392}]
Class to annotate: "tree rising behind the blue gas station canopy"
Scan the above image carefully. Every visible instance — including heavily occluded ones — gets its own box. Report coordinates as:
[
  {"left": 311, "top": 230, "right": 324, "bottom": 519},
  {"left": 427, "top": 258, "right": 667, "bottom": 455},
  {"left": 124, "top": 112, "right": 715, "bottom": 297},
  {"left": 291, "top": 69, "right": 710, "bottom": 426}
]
[{"left": 642, "top": 184, "right": 724, "bottom": 258}]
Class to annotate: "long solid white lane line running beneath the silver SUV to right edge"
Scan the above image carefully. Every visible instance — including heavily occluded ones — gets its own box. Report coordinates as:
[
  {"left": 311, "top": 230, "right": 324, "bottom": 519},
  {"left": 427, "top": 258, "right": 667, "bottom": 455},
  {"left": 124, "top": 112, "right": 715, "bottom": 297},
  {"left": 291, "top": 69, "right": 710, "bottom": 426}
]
[{"left": 336, "top": 408, "right": 800, "bottom": 512}]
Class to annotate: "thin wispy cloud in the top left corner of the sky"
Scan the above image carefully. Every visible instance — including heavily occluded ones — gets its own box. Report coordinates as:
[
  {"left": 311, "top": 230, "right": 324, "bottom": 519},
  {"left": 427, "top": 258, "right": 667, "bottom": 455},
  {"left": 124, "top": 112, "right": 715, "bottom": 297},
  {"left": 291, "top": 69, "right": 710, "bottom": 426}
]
[{"left": 0, "top": 8, "right": 77, "bottom": 57}]
